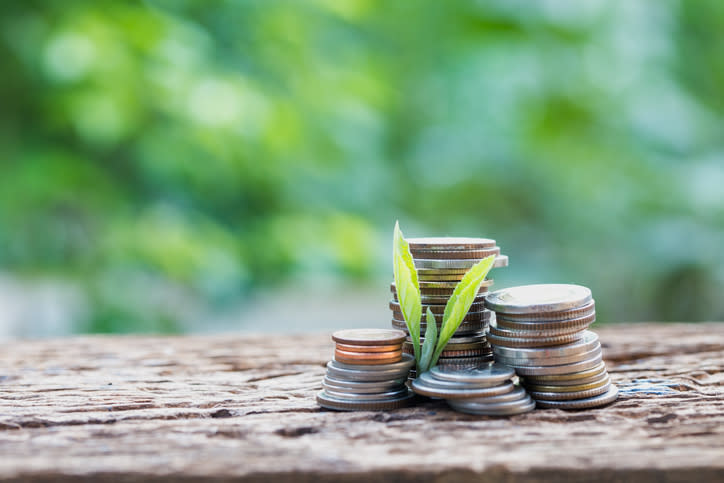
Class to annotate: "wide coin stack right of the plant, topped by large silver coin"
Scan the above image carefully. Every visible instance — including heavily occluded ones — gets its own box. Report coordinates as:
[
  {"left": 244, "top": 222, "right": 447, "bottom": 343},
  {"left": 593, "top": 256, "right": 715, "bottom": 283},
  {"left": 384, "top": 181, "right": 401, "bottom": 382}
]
[{"left": 485, "top": 284, "right": 618, "bottom": 409}]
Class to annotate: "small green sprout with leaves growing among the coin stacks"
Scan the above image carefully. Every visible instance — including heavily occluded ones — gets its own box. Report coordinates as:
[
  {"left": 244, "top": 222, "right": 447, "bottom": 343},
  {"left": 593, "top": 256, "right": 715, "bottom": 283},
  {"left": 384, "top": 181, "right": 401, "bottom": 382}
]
[{"left": 392, "top": 222, "right": 495, "bottom": 374}]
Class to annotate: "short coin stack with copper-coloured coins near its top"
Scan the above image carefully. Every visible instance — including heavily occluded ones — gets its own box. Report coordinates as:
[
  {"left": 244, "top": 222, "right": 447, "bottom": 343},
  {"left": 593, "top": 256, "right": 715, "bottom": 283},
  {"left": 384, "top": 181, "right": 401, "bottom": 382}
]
[{"left": 317, "top": 329, "right": 415, "bottom": 411}]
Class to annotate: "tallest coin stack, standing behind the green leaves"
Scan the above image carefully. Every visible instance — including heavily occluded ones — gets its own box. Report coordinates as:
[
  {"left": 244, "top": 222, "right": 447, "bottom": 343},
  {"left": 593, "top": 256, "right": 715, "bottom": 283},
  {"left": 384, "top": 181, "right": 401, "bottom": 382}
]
[{"left": 390, "top": 237, "right": 508, "bottom": 378}]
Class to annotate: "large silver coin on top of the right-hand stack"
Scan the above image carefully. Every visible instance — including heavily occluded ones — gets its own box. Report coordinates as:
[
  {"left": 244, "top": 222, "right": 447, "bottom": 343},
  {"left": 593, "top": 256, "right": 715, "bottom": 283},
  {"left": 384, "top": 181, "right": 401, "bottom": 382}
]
[{"left": 485, "top": 284, "right": 593, "bottom": 314}]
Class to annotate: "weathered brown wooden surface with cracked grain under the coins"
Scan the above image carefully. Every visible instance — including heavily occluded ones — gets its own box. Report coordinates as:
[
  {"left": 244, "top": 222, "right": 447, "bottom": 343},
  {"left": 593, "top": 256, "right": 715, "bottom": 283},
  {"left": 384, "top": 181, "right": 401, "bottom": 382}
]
[{"left": 0, "top": 323, "right": 724, "bottom": 483}]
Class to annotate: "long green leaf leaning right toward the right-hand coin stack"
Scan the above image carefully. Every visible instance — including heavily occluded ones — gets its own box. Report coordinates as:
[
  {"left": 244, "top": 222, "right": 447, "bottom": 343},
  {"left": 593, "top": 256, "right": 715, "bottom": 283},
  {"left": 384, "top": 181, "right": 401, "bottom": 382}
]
[{"left": 431, "top": 255, "right": 495, "bottom": 366}]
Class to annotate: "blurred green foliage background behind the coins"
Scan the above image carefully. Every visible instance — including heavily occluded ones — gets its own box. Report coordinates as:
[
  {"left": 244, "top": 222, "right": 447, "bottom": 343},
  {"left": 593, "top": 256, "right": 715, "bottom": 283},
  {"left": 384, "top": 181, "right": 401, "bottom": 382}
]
[{"left": 0, "top": 0, "right": 724, "bottom": 337}]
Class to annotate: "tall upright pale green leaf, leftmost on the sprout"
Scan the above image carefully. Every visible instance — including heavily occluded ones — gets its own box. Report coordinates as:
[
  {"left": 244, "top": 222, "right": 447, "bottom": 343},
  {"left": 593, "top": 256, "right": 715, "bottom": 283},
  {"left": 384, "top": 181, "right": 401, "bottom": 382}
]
[{"left": 392, "top": 222, "right": 422, "bottom": 364}]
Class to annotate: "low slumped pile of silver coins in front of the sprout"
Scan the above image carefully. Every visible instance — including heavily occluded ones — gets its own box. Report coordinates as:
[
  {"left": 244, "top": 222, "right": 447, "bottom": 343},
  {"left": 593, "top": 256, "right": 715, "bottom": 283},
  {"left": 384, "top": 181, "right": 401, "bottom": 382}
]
[{"left": 412, "top": 363, "right": 535, "bottom": 416}]
